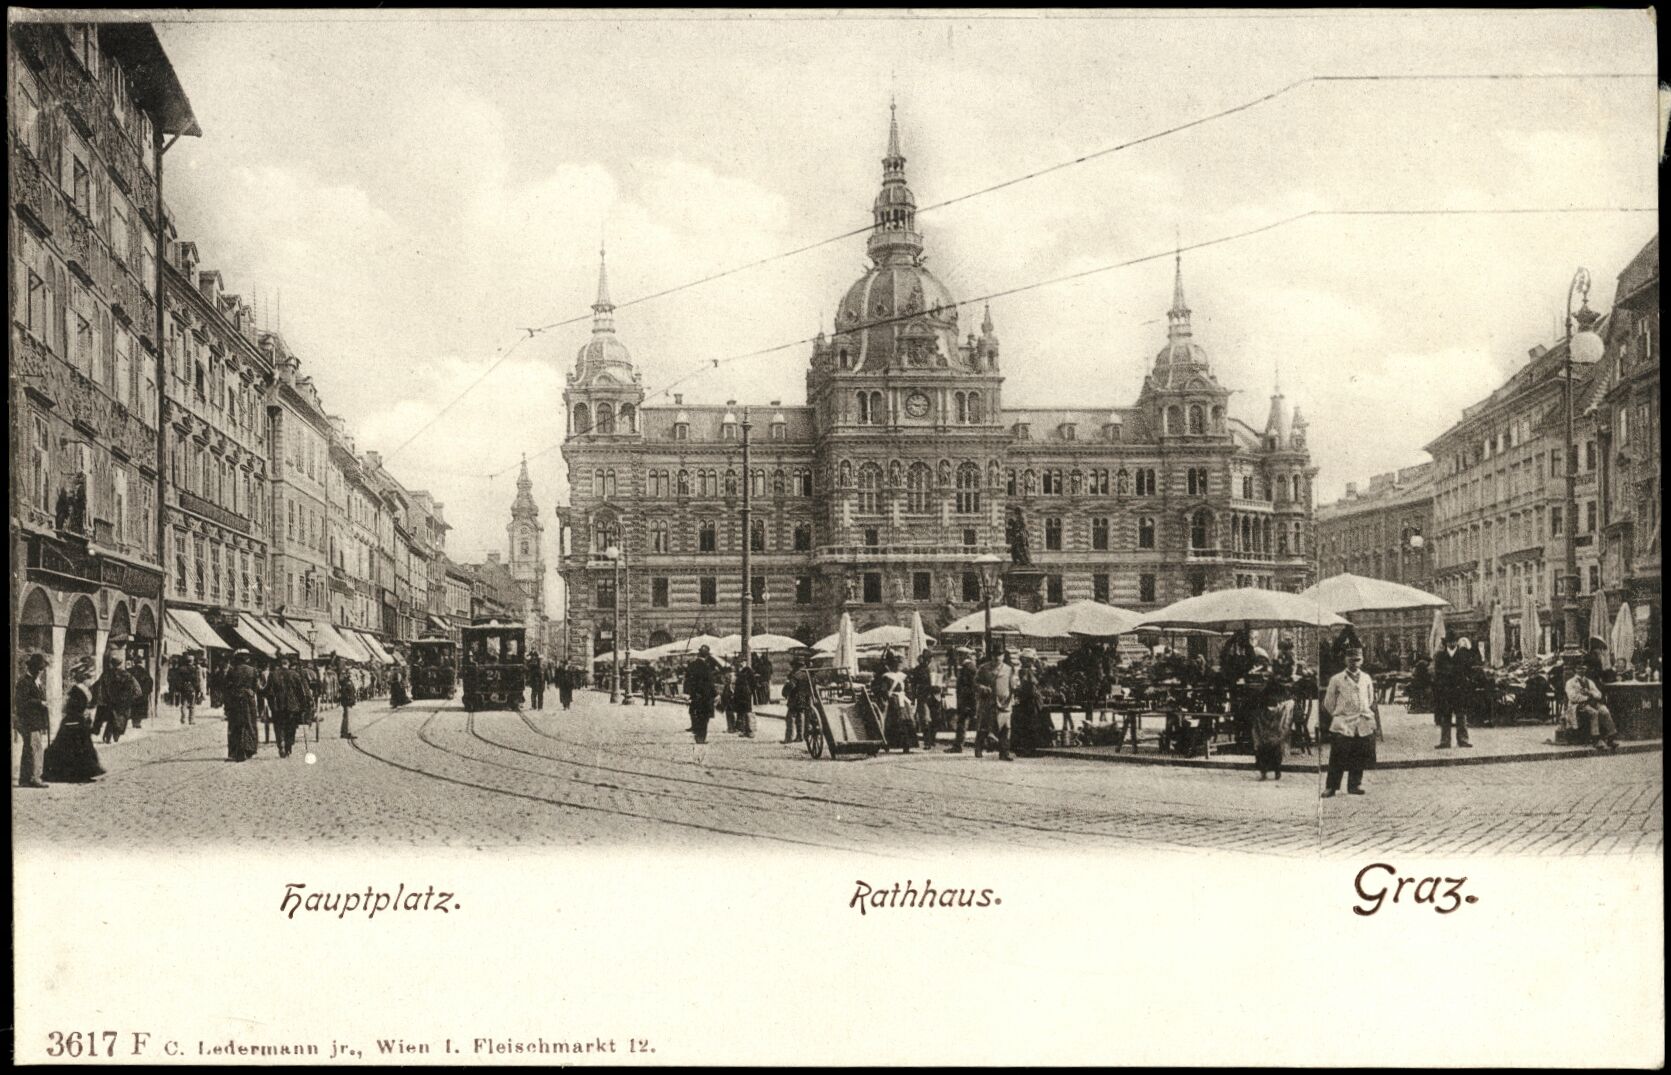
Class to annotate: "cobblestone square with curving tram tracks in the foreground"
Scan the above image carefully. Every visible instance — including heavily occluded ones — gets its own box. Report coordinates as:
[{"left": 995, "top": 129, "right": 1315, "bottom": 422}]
[{"left": 12, "top": 694, "right": 1664, "bottom": 856}]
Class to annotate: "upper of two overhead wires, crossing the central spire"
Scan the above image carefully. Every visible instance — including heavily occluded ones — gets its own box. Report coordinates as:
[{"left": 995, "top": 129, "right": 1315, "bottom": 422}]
[{"left": 375, "top": 72, "right": 1658, "bottom": 458}]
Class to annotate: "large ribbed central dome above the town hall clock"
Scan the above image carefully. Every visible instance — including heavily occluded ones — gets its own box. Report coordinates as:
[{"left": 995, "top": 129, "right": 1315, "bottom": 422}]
[{"left": 836, "top": 264, "right": 959, "bottom": 369}]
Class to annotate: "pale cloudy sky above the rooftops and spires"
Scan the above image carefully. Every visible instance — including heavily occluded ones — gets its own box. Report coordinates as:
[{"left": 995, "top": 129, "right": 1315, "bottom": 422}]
[{"left": 137, "top": 12, "right": 1661, "bottom": 607}]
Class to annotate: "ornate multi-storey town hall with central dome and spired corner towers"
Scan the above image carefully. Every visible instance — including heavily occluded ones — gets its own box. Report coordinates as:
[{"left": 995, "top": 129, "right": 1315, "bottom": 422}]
[{"left": 558, "top": 109, "right": 1315, "bottom": 660}]
